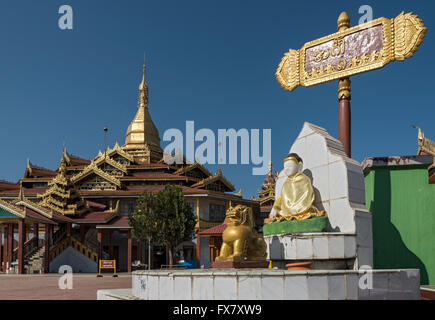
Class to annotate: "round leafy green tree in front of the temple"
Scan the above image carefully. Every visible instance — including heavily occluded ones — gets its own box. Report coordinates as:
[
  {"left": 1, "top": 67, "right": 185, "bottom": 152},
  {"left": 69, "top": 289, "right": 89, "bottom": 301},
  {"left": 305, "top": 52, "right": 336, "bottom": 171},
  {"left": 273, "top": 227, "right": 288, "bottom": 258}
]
[{"left": 129, "top": 186, "right": 196, "bottom": 265}]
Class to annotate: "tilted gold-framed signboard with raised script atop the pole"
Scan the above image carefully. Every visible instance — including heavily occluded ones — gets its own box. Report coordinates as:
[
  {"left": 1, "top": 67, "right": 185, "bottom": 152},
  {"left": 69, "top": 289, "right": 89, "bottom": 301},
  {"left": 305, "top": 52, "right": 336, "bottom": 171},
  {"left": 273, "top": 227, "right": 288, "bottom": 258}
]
[{"left": 275, "top": 12, "right": 427, "bottom": 91}]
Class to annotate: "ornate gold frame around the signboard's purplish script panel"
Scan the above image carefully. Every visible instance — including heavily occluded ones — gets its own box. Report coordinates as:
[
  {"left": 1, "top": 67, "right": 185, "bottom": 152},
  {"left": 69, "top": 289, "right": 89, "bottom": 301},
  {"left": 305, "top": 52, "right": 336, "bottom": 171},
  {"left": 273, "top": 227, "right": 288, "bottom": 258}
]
[{"left": 275, "top": 12, "right": 427, "bottom": 91}]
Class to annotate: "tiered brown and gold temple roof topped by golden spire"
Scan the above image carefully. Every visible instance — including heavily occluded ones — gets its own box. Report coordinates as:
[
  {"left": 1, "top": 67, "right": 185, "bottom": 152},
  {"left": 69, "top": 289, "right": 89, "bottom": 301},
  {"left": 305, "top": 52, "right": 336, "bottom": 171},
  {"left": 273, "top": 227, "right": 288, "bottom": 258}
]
[{"left": 0, "top": 61, "right": 249, "bottom": 223}]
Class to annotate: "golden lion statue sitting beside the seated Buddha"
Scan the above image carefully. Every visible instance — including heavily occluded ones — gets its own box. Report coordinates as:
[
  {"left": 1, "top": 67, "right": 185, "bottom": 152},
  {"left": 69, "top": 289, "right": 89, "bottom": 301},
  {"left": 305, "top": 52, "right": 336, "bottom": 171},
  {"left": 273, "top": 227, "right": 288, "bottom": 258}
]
[{"left": 216, "top": 205, "right": 267, "bottom": 261}]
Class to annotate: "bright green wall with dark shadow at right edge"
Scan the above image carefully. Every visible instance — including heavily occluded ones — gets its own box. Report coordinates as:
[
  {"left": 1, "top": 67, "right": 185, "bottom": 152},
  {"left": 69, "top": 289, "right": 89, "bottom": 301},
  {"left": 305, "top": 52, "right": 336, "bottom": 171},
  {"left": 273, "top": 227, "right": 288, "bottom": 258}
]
[{"left": 365, "top": 165, "right": 435, "bottom": 284}]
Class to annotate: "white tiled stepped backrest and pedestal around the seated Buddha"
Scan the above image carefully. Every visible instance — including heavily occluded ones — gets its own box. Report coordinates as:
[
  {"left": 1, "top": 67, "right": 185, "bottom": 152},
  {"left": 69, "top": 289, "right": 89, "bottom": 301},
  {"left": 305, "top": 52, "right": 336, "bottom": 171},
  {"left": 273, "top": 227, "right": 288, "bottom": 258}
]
[{"left": 280, "top": 122, "right": 373, "bottom": 269}]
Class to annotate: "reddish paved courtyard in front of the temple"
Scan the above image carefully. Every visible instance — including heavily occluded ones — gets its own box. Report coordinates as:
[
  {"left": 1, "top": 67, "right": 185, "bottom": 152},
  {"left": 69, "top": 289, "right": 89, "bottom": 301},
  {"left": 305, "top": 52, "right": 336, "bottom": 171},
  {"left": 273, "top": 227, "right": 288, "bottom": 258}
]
[{"left": 0, "top": 274, "right": 131, "bottom": 300}]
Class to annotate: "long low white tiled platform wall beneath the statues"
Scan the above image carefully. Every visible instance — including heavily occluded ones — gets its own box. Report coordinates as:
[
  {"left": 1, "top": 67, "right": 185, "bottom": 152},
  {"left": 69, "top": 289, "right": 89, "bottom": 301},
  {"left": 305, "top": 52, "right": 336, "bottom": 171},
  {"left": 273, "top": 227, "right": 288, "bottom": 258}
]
[{"left": 98, "top": 269, "right": 420, "bottom": 300}]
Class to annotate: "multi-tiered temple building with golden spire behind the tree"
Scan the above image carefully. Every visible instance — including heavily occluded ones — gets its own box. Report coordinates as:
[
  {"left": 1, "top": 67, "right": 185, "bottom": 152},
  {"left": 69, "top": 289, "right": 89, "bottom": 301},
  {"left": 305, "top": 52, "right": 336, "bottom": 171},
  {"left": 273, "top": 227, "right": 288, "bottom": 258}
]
[{"left": 0, "top": 66, "right": 260, "bottom": 274}]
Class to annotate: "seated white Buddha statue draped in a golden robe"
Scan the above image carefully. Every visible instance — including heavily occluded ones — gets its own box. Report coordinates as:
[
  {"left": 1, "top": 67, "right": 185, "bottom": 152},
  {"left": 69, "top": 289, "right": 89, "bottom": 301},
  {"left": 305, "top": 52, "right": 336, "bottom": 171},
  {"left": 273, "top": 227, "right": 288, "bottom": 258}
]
[{"left": 269, "top": 153, "right": 326, "bottom": 222}]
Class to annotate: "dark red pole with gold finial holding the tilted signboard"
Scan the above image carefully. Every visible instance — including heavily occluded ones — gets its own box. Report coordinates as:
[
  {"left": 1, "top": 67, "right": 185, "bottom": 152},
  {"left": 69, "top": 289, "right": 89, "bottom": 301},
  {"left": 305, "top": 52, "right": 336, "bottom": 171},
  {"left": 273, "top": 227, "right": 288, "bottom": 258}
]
[{"left": 337, "top": 12, "right": 352, "bottom": 158}]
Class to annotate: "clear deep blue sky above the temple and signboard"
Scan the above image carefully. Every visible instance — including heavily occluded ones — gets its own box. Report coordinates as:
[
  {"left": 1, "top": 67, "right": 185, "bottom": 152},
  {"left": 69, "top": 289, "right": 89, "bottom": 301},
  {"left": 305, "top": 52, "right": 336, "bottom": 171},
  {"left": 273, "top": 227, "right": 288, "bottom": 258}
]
[{"left": 0, "top": 0, "right": 435, "bottom": 197}]
